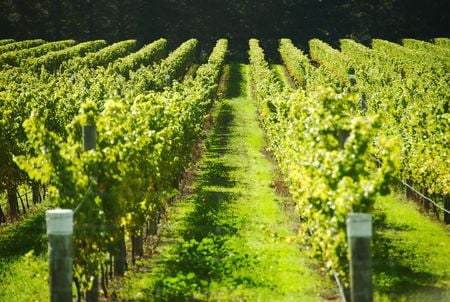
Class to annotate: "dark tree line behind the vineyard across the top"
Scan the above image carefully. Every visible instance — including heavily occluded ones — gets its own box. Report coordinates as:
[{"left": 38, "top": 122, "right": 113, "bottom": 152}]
[{"left": 0, "top": 0, "right": 450, "bottom": 56}]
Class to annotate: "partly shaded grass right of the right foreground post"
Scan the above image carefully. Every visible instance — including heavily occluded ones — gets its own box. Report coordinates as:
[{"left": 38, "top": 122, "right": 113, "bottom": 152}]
[{"left": 373, "top": 194, "right": 450, "bottom": 301}]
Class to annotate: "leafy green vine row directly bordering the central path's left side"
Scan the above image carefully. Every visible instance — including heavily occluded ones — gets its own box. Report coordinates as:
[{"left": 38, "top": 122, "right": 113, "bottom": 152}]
[{"left": 15, "top": 40, "right": 227, "bottom": 289}]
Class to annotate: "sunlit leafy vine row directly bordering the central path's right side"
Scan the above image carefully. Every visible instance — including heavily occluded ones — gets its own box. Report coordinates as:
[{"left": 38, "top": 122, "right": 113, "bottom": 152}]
[{"left": 249, "top": 40, "right": 397, "bottom": 282}]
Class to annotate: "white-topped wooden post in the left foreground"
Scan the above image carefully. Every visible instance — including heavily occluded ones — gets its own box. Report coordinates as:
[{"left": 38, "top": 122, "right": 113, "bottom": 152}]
[{"left": 45, "top": 209, "right": 73, "bottom": 302}]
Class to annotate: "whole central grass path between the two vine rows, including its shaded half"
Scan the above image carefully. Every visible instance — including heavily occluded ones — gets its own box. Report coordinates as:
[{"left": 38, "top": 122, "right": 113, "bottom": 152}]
[{"left": 122, "top": 64, "right": 335, "bottom": 301}]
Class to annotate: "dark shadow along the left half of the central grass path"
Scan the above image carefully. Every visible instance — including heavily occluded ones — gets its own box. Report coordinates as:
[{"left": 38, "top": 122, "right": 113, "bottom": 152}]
[{"left": 147, "top": 64, "right": 257, "bottom": 301}]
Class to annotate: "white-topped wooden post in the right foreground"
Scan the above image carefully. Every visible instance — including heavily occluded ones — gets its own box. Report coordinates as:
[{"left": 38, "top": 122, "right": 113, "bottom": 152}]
[{"left": 347, "top": 213, "right": 373, "bottom": 302}]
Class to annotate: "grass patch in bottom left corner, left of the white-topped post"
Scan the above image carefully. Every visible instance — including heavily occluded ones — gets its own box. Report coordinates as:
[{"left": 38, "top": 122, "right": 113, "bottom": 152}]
[{"left": 0, "top": 206, "right": 49, "bottom": 302}]
